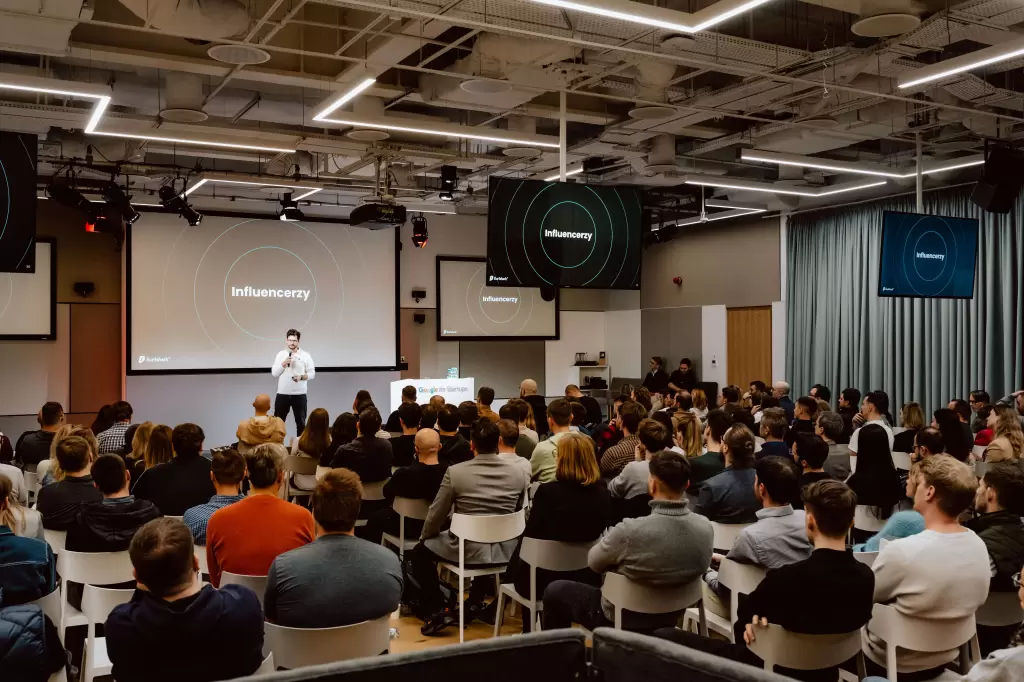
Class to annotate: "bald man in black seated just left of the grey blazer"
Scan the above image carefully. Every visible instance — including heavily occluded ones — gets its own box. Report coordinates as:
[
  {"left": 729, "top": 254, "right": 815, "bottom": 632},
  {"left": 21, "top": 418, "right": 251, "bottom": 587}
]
[{"left": 364, "top": 429, "right": 446, "bottom": 545}]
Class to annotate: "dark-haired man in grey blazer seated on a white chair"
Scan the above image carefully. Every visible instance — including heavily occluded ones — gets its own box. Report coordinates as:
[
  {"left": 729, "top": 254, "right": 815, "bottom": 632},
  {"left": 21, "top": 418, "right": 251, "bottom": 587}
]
[{"left": 412, "top": 419, "right": 529, "bottom": 635}]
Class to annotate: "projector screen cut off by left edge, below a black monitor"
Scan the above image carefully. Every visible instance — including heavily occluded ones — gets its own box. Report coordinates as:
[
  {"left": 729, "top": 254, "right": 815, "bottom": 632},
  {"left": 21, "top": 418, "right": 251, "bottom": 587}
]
[{"left": 0, "top": 239, "right": 57, "bottom": 341}]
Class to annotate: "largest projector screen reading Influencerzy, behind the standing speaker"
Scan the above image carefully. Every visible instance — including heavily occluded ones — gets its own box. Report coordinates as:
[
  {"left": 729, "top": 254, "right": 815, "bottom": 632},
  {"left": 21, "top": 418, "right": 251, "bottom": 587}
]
[{"left": 128, "top": 213, "right": 398, "bottom": 374}]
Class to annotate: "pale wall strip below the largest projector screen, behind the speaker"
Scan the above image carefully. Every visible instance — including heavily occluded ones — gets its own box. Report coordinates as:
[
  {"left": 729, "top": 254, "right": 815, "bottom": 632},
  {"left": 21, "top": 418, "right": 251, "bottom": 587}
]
[{"left": 125, "top": 372, "right": 398, "bottom": 447}]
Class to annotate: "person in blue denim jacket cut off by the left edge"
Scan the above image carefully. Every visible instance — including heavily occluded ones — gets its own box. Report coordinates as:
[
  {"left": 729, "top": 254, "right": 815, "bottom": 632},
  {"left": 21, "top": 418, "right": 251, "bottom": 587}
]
[{"left": 0, "top": 474, "right": 56, "bottom": 602}]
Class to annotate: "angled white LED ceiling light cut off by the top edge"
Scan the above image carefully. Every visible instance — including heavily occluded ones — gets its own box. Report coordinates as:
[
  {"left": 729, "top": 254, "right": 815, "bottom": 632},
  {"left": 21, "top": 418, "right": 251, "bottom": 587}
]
[{"left": 534, "top": 0, "right": 769, "bottom": 33}]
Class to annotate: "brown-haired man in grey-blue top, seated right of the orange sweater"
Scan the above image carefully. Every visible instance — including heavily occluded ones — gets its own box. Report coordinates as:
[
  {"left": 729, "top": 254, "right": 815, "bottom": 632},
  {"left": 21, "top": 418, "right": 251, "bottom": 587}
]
[{"left": 263, "top": 469, "right": 402, "bottom": 628}]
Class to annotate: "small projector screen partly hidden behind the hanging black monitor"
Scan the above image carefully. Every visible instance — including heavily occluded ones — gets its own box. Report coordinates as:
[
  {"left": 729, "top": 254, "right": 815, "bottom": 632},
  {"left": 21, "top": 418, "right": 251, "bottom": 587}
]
[{"left": 437, "top": 256, "right": 558, "bottom": 341}]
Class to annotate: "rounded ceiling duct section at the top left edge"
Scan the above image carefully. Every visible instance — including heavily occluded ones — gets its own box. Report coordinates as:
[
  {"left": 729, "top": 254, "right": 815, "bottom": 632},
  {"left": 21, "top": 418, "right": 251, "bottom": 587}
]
[{"left": 115, "top": 0, "right": 249, "bottom": 40}]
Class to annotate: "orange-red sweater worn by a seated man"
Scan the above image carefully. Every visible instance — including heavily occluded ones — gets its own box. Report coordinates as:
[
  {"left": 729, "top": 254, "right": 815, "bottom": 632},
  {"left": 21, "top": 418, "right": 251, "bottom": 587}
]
[{"left": 206, "top": 495, "right": 316, "bottom": 587}]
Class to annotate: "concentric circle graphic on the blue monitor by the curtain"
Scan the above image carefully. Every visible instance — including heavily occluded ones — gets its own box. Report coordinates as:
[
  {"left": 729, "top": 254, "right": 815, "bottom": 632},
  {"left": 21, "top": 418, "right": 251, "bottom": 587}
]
[{"left": 896, "top": 216, "right": 959, "bottom": 296}]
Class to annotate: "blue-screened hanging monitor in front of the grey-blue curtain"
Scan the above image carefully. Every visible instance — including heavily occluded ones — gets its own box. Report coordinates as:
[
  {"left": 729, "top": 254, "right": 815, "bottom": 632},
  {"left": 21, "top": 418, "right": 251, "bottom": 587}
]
[{"left": 879, "top": 211, "right": 978, "bottom": 298}]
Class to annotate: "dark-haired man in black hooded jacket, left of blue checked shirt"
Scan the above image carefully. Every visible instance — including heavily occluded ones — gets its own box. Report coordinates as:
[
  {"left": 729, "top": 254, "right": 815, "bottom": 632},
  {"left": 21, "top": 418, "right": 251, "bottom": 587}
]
[{"left": 65, "top": 455, "right": 161, "bottom": 608}]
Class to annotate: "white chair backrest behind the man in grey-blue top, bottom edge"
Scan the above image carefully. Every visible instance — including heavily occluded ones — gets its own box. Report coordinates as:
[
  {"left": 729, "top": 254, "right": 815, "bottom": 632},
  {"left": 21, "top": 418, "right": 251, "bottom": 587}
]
[{"left": 263, "top": 615, "right": 391, "bottom": 670}]
